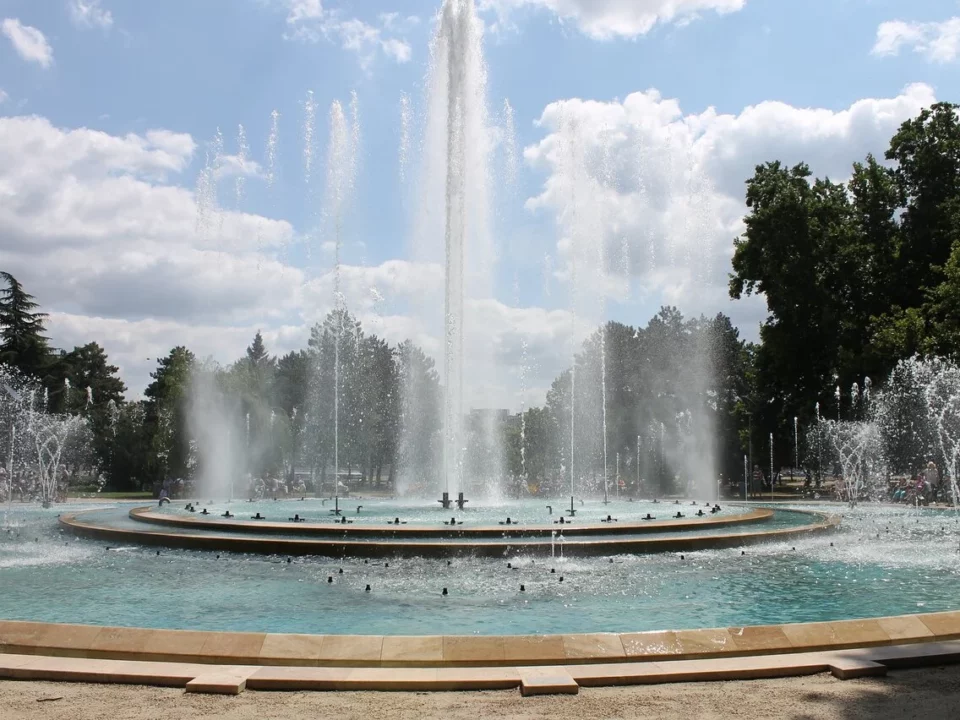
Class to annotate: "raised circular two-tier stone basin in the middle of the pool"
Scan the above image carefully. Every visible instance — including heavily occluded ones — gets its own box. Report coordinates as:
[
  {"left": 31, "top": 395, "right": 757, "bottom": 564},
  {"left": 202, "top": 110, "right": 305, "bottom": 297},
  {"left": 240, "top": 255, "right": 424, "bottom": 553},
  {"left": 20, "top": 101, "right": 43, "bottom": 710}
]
[{"left": 54, "top": 501, "right": 835, "bottom": 558}]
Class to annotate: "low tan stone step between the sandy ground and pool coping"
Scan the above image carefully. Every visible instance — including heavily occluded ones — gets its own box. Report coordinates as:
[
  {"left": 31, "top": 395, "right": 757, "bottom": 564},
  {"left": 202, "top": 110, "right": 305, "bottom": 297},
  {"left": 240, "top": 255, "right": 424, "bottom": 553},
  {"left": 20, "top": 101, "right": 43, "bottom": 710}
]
[{"left": 0, "top": 642, "right": 960, "bottom": 695}]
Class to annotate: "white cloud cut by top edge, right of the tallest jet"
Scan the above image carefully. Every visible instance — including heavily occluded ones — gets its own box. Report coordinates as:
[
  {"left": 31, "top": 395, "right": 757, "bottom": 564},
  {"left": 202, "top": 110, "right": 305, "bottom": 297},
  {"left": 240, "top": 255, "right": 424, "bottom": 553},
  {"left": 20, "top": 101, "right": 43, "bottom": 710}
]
[{"left": 480, "top": 0, "right": 746, "bottom": 40}]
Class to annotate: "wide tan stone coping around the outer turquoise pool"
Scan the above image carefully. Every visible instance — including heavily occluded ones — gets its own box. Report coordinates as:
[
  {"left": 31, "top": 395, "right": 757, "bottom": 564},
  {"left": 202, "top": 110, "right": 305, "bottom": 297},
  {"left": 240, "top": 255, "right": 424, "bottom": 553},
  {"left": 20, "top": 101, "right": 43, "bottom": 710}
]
[{"left": 0, "top": 611, "right": 960, "bottom": 668}]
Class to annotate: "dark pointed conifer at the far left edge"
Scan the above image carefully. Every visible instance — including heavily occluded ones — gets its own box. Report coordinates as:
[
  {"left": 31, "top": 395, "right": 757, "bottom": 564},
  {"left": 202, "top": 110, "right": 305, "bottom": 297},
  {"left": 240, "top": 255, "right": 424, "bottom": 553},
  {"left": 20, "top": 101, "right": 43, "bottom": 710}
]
[{"left": 0, "top": 272, "right": 51, "bottom": 380}]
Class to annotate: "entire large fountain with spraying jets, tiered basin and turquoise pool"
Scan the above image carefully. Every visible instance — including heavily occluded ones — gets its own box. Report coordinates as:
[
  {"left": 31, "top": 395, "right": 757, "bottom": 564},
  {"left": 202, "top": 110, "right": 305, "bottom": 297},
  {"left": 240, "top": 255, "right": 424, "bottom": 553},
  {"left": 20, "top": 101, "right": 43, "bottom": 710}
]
[{"left": 0, "top": 0, "right": 960, "bottom": 680}]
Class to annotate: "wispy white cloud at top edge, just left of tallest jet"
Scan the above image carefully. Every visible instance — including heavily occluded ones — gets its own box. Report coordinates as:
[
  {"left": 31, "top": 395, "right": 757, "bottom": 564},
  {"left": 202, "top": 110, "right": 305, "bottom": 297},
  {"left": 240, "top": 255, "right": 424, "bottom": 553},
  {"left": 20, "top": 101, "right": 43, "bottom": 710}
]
[{"left": 280, "top": 0, "right": 419, "bottom": 70}]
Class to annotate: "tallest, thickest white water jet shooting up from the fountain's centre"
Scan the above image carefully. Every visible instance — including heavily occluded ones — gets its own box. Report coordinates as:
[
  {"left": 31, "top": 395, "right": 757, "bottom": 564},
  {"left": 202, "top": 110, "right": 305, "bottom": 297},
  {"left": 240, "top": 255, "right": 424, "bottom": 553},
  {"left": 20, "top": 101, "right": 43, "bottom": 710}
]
[{"left": 415, "top": 0, "right": 494, "bottom": 493}]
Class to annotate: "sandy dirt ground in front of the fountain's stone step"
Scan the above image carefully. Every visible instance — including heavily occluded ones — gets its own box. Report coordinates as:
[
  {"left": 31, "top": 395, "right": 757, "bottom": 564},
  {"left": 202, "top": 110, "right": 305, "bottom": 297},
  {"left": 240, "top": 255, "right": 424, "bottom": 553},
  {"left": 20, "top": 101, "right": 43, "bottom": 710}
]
[{"left": 0, "top": 666, "right": 960, "bottom": 720}]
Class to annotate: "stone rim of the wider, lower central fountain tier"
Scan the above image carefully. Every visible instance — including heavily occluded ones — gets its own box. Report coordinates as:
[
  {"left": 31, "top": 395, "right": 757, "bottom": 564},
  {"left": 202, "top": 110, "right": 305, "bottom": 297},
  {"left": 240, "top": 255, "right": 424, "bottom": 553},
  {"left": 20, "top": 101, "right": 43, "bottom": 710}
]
[{"left": 59, "top": 510, "right": 840, "bottom": 558}]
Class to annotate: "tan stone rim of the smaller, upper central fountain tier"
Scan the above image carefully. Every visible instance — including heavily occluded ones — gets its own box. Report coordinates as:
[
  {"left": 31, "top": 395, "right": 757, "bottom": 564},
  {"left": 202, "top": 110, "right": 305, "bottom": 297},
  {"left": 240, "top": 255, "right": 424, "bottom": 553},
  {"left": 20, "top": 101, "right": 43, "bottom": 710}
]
[{"left": 129, "top": 503, "right": 774, "bottom": 539}]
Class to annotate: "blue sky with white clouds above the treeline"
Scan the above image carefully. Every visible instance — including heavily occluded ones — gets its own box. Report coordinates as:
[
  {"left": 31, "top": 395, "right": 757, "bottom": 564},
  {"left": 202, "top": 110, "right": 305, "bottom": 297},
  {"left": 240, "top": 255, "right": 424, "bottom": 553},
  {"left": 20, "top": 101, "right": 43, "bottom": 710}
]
[{"left": 0, "top": 0, "right": 960, "bottom": 409}]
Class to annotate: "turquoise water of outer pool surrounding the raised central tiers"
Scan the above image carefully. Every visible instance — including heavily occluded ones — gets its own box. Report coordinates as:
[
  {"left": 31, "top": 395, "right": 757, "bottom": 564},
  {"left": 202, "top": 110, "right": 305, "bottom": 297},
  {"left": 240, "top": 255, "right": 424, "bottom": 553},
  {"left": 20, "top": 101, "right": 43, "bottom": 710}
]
[{"left": 0, "top": 504, "right": 960, "bottom": 635}]
